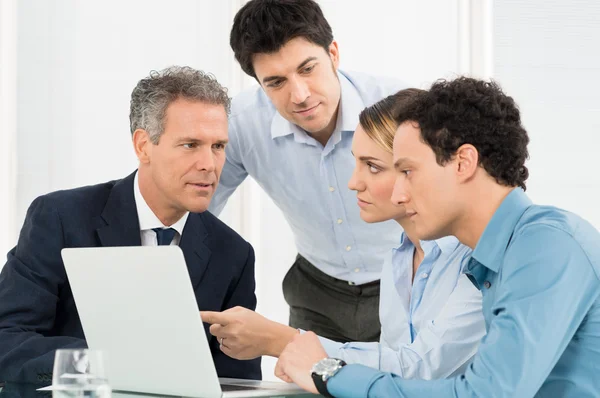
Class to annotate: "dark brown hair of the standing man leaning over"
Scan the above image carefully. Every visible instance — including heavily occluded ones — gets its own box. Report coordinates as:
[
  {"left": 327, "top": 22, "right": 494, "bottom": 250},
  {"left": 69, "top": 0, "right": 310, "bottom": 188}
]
[{"left": 229, "top": 0, "right": 333, "bottom": 78}]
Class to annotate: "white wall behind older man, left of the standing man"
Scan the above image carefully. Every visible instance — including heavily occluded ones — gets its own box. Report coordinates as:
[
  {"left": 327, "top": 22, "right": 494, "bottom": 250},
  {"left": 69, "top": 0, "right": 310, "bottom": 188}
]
[{"left": 17, "top": 0, "right": 244, "bottom": 224}]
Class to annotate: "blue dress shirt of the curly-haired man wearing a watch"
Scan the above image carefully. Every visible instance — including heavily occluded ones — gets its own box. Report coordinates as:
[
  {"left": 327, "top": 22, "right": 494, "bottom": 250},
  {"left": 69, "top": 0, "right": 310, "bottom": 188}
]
[{"left": 328, "top": 188, "right": 600, "bottom": 398}]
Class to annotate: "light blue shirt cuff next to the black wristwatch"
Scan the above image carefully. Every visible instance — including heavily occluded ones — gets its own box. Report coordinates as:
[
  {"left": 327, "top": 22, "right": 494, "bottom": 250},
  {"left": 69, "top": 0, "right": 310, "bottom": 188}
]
[{"left": 327, "top": 365, "right": 381, "bottom": 398}]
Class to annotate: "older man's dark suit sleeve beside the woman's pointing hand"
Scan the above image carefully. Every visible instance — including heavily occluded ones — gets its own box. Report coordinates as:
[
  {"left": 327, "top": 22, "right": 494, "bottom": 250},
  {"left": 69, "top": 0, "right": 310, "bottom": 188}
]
[{"left": 210, "top": 243, "right": 262, "bottom": 380}]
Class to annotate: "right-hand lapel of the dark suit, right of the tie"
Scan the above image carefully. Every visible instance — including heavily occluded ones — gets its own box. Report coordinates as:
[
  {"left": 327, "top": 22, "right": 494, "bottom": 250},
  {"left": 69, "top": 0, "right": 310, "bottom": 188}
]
[{"left": 179, "top": 213, "right": 211, "bottom": 289}]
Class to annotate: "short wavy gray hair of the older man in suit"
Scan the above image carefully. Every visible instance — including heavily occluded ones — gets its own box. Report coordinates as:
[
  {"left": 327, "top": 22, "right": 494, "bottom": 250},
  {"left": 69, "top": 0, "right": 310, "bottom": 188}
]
[{"left": 129, "top": 66, "right": 231, "bottom": 144}]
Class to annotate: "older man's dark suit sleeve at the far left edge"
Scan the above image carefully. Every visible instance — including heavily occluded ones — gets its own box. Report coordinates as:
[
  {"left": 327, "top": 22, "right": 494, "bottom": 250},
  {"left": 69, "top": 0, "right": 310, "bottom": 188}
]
[{"left": 0, "top": 197, "right": 86, "bottom": 383}]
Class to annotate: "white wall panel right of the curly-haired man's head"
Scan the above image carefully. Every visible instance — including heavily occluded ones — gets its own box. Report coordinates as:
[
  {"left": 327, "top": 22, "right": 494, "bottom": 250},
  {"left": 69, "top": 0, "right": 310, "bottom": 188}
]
[{"left": 493, "top": 0, "right": 600, "bottom": 229}]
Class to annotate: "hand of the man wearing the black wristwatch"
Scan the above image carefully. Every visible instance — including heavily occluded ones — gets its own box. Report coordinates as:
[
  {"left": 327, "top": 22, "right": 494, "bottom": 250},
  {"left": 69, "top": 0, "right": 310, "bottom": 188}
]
[{"left": 275, "top": 332, "right": 327, "bottom": 394}]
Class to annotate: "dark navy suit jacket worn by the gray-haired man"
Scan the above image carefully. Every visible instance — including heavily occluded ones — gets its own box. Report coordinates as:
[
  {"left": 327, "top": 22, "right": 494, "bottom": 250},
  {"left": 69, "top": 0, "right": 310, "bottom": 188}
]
[{"left": 0, "top": 173, "right": 261, "bottom": 383}]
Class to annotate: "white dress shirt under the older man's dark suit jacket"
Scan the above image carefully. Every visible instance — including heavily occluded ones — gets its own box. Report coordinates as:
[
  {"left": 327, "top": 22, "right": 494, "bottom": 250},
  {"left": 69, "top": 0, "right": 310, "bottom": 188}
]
[{"left": 133, "top": 172, "right": 190, "bottom": 246}]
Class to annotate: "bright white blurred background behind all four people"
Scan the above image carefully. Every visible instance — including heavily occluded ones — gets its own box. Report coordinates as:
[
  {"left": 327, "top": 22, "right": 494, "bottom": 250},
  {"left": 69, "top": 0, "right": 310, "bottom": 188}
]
[{"left": 0, "top": 0, "right": 600, "bottom": 379}]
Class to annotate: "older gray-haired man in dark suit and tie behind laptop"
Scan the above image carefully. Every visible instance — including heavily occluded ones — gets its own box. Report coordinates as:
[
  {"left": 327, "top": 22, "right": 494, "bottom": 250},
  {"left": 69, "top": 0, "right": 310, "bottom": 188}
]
[{"left": 0, "top": 67, "right": 261, "bottom": 383}]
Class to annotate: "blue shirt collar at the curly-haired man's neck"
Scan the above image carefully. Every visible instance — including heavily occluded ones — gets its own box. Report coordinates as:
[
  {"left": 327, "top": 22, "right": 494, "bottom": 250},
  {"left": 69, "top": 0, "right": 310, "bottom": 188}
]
[{"left": 472, "top": 188, "right": 532, "bottom": 272}]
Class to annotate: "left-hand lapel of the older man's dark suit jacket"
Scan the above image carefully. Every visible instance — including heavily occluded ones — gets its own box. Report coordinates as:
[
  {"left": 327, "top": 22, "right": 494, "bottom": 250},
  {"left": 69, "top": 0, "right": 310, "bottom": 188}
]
[{"left": 96, "top": 172, "right": 142, "bottom": 246}]
